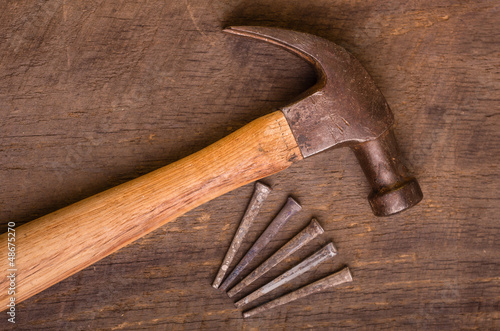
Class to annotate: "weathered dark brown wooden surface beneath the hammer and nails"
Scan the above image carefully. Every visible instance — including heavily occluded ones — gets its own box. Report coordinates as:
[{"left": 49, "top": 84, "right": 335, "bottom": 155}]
[{"left": 0, "top": 0, "right": 500, "bottom": 330}]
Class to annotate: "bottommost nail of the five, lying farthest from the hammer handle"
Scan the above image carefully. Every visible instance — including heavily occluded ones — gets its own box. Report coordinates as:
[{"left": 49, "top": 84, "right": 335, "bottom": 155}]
[{"left": 243, "top": 267, "right": 352, "bottom": 318}]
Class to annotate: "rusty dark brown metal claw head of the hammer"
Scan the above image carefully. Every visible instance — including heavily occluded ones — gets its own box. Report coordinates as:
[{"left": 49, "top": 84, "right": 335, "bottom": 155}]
[{"left": 224, "top": 26, "right": 422, "bottom": 216}]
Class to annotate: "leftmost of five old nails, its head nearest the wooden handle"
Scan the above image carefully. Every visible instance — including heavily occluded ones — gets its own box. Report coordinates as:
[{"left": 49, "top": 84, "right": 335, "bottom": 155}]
[{"left": 212, "top": 182, "right": 272, "bottom": 288}]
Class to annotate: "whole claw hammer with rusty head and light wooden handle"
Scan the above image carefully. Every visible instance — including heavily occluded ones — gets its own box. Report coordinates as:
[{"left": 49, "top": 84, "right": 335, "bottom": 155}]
[{"left": 0, "top": 27, "right": 422, "bottom": 309}]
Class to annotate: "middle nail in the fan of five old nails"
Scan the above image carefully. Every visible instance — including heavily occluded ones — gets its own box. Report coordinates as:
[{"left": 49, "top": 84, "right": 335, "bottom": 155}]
[{"left": 227, "top": 218, "right": 325, "bottom": 298}]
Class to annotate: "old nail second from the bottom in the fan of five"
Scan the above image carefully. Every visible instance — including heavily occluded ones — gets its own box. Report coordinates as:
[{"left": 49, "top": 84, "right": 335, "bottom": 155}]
[{"left": 234, "top": 243, "right": 337, "bottom": 308}]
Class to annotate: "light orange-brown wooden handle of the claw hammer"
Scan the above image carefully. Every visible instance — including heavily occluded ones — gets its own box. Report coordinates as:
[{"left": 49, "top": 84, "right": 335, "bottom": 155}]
[{"left": 0, "top": 111, "right": 302, "bottom": 310}]
